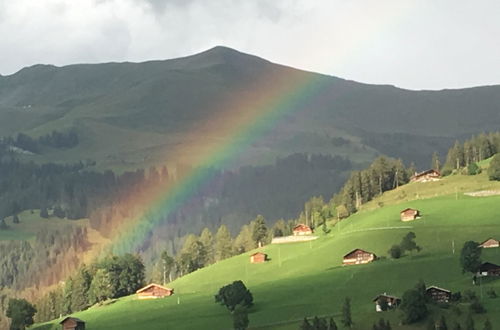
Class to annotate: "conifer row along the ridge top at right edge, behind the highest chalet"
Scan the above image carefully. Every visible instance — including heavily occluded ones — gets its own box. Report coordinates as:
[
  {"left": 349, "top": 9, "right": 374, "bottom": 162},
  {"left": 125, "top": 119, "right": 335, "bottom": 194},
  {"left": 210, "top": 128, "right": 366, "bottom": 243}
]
[{"left": 442, "top": 132, "right": 500, "bottom": 175}]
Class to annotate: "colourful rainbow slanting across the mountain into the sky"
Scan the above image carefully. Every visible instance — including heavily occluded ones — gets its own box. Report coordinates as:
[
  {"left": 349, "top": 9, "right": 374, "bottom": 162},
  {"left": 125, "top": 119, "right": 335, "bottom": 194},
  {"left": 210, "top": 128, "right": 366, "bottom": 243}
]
[{"left": 100, "top": 4, "right": 412, "bottom": 253}]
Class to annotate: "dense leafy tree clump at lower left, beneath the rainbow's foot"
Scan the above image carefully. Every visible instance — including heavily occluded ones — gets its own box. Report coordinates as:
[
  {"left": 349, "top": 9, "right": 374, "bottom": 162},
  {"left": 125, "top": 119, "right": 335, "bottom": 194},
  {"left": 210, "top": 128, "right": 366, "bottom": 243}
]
[{"left": 36, "top": 254, "right": 145, "bottom": 322}]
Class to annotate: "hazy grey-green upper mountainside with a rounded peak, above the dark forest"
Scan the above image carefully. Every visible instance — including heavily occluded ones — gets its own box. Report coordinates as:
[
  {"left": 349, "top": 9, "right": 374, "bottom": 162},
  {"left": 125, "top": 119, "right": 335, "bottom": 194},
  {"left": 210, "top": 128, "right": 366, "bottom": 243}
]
[{"left": 0, "top": 47, "right": 500, "bottom": 169}]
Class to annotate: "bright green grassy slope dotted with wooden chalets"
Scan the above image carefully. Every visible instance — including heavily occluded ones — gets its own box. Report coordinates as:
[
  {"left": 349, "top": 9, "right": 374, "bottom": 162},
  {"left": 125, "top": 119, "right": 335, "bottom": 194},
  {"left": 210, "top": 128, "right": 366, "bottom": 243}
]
[{"left": 35, "top": 173, "right": 500, "bottom": 330}]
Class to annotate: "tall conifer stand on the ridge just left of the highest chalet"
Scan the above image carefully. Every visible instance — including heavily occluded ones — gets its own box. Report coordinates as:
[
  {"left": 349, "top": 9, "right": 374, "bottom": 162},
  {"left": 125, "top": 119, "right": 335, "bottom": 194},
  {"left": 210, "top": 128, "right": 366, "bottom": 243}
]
[{"left": 333, "top": 156, "right": 415, "bottom": 217}]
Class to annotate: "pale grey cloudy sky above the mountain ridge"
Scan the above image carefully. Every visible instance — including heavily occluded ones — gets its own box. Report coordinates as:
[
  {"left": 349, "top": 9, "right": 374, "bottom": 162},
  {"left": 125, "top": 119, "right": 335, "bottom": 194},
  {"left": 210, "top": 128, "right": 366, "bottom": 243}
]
[{"left": 0, "top": 0, "right": 500, "bottom": 89}]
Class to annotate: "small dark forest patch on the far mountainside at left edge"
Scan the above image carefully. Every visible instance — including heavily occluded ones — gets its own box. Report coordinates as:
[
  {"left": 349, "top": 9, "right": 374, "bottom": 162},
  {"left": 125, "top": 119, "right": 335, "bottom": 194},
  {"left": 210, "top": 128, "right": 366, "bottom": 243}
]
[{"left": 2, "top": 129, "right": 79, "bottom": 153}]
